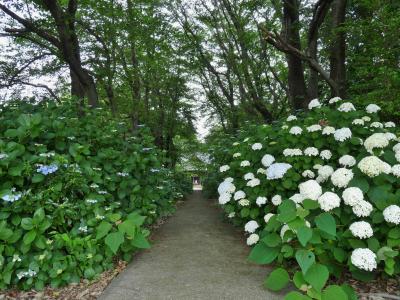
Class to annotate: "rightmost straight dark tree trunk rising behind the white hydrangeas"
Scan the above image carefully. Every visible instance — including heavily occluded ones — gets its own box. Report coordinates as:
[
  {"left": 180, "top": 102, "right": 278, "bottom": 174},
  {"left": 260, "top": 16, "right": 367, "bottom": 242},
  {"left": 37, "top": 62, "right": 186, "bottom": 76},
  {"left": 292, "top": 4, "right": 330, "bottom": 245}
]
[{"left": 330, "top": 0, "right": 347, "bottom": 98}]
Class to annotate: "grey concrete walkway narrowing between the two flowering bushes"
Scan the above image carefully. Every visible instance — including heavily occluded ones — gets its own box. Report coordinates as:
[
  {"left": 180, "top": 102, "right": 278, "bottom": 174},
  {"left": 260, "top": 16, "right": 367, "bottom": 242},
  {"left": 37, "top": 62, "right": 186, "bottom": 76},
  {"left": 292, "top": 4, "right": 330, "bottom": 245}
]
[{"left": 100, "top": 191, "right": 283, "bottom": 300}]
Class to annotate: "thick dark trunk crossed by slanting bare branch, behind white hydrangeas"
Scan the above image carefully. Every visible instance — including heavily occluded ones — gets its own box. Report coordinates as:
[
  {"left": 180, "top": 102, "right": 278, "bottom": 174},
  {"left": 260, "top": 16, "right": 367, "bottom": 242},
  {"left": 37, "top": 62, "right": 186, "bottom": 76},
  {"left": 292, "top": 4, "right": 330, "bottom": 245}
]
[{"left": 282, "top": 0, "right": 309, "bottom": 110}]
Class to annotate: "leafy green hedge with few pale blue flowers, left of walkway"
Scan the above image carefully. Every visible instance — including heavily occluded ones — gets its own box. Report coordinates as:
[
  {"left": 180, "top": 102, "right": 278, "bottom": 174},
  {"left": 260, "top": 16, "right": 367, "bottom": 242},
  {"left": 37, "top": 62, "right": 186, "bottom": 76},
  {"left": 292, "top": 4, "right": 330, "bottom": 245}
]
[{"left": 0, "top": 103, "right": 189, "bottom": 289}]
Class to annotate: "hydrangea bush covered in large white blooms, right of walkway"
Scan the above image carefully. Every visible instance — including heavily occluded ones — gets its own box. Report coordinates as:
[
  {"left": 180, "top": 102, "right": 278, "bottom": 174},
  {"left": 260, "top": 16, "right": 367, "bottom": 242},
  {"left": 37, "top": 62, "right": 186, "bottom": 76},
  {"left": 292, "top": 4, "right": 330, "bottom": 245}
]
[{"left": 206, "top": 98, "right": 400, "bottom": 299}]
